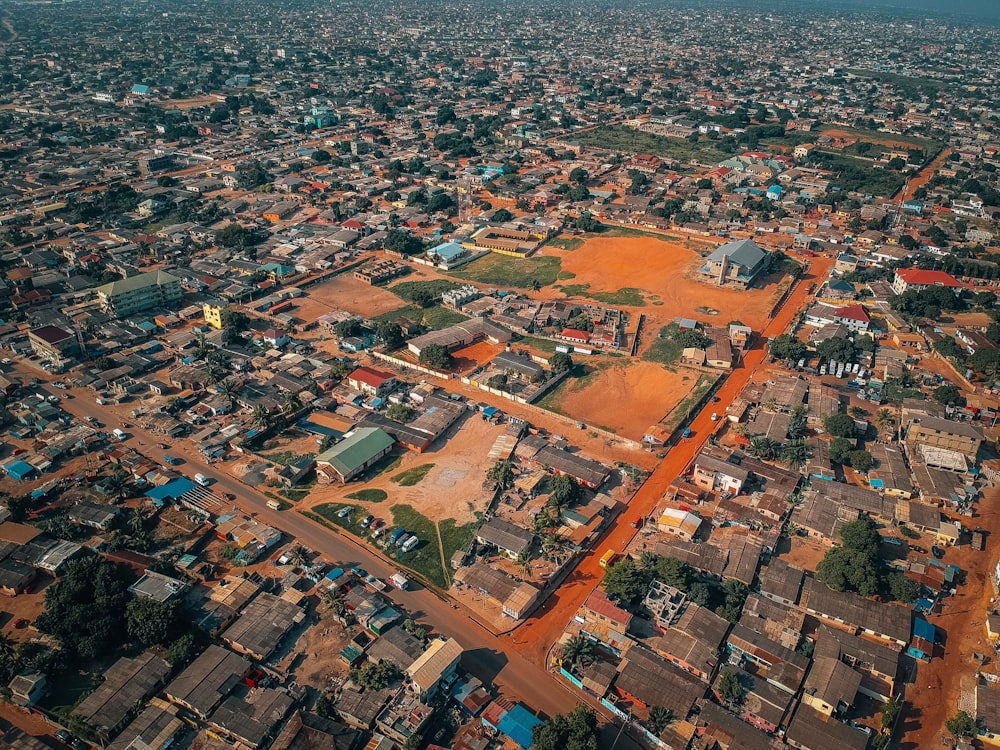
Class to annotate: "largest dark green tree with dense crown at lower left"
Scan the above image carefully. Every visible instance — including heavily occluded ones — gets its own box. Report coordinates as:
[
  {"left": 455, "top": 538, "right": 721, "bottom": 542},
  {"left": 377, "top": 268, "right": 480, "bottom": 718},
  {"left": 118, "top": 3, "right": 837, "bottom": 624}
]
[{"left": 35, "top": 555, "right": 135, "bottom": 660}]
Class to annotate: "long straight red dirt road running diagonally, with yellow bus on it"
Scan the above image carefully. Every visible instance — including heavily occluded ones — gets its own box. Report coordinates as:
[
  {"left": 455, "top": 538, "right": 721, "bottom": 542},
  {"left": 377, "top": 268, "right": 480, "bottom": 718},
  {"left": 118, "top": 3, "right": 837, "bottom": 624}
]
[{"left": 511, "top": 257, "right": 833, "bottom": 663}]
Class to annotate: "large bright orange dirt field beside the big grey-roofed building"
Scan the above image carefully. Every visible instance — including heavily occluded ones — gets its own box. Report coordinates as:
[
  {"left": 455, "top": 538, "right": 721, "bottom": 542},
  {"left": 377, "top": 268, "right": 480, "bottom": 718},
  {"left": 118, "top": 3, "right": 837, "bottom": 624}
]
[{"left": 560, "top": 237, "right": 775, "bottom": 330}]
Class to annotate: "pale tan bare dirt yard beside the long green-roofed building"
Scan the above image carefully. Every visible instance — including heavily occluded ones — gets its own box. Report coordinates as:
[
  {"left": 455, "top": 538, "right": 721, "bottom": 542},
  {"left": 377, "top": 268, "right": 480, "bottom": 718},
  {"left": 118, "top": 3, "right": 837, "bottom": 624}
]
[{"left": 298, "top": 414, "right": 504, "bottom": 525}]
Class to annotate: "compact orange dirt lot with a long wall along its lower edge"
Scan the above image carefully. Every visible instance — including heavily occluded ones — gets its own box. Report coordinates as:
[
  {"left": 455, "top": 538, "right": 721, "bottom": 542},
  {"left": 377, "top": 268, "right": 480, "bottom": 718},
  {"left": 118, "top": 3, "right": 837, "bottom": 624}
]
[{"left": 556, "top": 362, "right": 698, "bottom": 440}]
